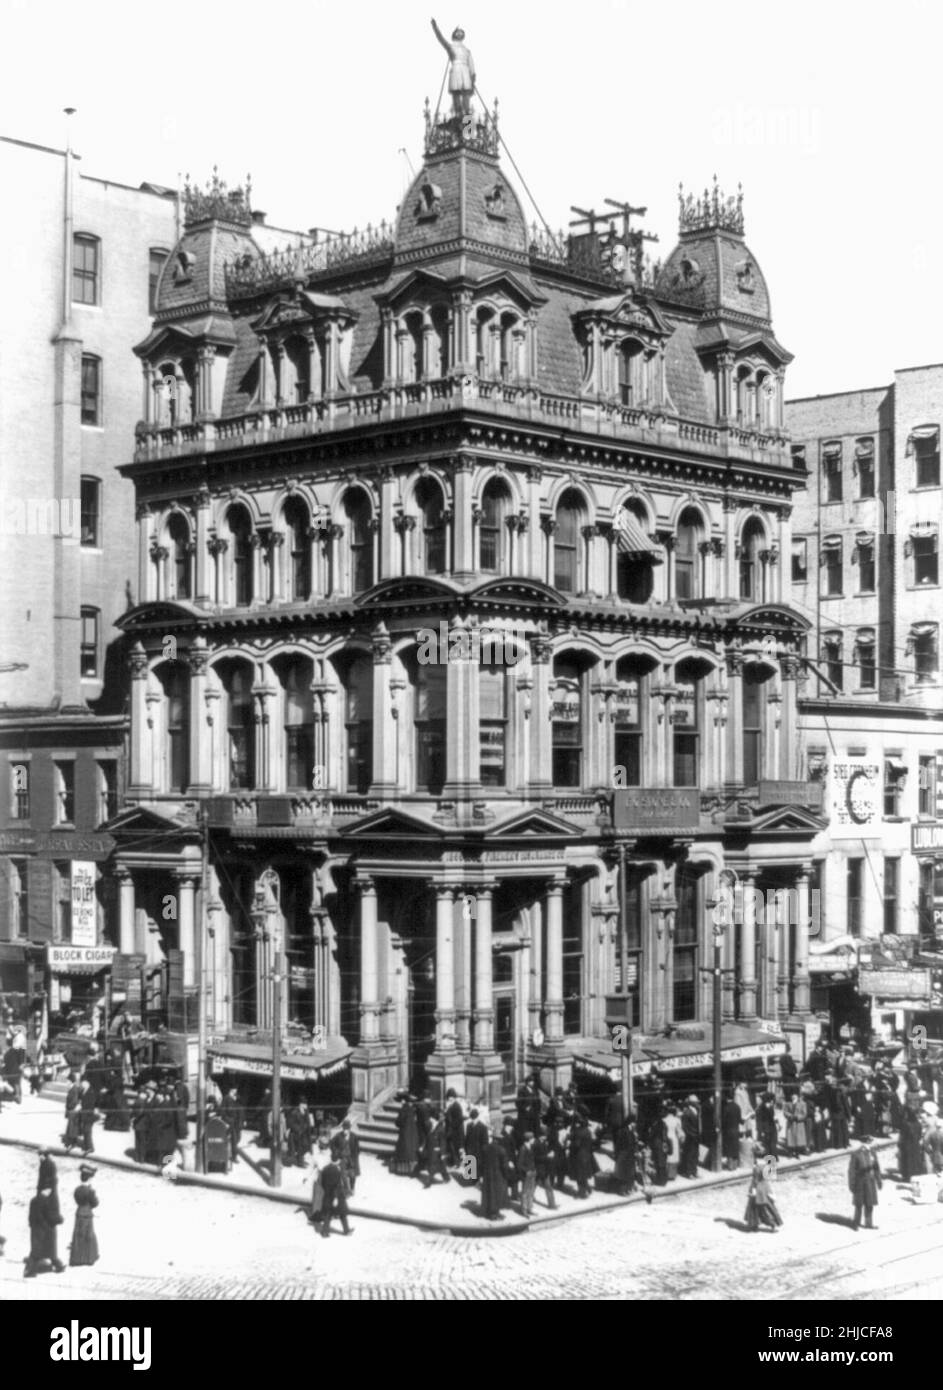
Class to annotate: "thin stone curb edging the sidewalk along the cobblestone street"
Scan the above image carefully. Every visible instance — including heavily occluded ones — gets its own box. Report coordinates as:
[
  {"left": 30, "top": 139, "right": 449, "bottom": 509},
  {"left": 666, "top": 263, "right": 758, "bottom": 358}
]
[{"left": 0, "top": 1136, "right": 897, "bottom": 1240}]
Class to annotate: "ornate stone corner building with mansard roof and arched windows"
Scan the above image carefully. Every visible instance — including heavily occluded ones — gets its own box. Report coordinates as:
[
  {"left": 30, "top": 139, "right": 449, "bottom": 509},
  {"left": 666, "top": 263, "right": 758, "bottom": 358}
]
[{"left": 111, "top": 78, "right": 821, "bottom": 1109}]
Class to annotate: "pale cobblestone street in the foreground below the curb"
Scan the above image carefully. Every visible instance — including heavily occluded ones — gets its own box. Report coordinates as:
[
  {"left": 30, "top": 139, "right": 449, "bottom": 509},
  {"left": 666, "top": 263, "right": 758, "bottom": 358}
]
[{"left": 0, "top": 1150, "right": 943, "bottom": 1301}]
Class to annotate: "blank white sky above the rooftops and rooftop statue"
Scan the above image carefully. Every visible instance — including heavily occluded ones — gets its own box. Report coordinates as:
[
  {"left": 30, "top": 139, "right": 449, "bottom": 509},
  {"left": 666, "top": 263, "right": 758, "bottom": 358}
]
[{"left": 0, "top": 0, "right": 943, "bottom": 396}]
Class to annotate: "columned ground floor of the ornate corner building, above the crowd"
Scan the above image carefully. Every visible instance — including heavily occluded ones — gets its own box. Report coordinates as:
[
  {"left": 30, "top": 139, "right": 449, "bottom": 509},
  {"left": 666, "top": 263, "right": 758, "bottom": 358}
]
[{"left": 110, "top": 809, "right": 816, "bottom": 1112}]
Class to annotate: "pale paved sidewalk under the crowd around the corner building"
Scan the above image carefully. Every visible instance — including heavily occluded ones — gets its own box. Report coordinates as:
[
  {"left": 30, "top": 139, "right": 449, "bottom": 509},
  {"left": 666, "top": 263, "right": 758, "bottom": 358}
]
[{"left": 0, "top": 1094, "right": 894, "bottom": 1237}]
